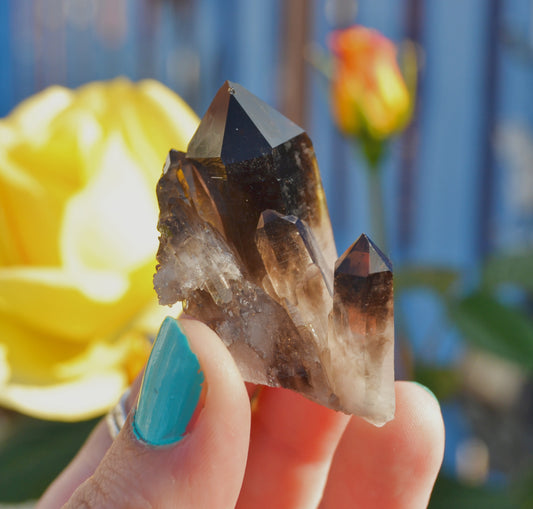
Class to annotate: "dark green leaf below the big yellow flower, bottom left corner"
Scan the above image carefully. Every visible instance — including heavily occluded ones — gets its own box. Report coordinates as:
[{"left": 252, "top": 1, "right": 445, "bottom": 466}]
[{"left": 0, "top": 416, "right": 97, "bottom": 502}]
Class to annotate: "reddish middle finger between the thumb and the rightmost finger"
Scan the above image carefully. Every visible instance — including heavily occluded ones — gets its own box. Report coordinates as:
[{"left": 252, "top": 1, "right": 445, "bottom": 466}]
[{"left": 237, "top": 387, "right": 348, "bottom": 509}]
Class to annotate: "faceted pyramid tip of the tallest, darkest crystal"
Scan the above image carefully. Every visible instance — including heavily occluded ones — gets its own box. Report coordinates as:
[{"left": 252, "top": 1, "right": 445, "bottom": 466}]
[{"left": 187, "top": 81, "right": 304, "bottom": 165}]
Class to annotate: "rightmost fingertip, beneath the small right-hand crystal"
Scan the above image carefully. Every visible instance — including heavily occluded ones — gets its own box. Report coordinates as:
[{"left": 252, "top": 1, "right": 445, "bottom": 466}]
[{"left": 320, "top": 382, "right": 444, "bottom": 509}]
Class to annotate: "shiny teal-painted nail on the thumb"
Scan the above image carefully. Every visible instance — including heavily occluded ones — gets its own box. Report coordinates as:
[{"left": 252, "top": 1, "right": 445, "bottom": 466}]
[{"left": 133, "top": 317, "right": 204, "bottom": 446}]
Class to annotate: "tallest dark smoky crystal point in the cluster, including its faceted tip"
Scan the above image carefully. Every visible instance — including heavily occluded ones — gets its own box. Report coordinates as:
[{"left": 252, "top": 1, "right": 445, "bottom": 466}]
[{"left": 187, "top": 81, "right": 336, "bottom": 279}]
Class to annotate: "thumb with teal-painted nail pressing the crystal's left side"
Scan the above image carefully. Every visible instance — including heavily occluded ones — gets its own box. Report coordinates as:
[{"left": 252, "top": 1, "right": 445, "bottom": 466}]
[{"left": 56, "top": 318, "right": 250, "bottom": 508}]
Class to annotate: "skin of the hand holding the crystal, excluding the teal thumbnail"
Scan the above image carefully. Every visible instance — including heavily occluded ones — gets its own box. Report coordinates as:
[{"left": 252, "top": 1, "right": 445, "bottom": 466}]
[{"left": 37, "top": 320, "right": 444, "bottom": 509}]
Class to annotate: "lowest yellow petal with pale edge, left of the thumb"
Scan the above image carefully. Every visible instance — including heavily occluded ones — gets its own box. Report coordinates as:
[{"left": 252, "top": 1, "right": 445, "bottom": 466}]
[{"left": 0, "top": 317, "right": 144, "bottom": 420}]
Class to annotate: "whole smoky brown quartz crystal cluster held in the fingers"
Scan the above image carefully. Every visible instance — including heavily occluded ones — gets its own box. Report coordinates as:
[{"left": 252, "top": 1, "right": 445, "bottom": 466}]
[{"left": 154, "top": 82, "right": 394, "bottom": 425}]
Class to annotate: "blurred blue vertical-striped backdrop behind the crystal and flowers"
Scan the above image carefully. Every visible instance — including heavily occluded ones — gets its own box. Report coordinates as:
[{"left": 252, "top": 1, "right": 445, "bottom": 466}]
[{"left": 0, "top": 0, "right": 533, "bottom": 507}]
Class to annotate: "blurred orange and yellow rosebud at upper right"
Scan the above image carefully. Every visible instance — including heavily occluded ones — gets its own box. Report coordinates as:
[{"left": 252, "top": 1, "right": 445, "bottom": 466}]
[{"left": 330, "top": 26, "right": 412, "bottom": 140}]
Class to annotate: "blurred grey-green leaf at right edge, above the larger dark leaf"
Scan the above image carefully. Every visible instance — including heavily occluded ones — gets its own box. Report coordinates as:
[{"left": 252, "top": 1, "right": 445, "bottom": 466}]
[{"left": 481, "top": 251, "right": 533, "bottom": 292}]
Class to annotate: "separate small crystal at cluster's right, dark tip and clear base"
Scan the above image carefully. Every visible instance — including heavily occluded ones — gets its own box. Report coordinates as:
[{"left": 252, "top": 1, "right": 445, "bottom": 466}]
[{"left": 328, "top": 234, "right": 394, "bottom": 425}]
